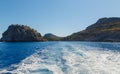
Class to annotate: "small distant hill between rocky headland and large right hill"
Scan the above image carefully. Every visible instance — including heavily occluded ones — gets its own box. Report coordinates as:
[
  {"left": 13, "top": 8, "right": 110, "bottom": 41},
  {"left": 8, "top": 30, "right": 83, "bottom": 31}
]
[{"left": 43, "top": 33, "right": 62, "bottom": 41}]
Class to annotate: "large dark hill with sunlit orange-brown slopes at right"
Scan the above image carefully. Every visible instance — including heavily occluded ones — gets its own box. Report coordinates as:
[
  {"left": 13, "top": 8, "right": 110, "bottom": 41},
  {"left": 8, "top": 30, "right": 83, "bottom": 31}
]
[{"left": 62, "top": 17, "right": 120, "bottom": 42}]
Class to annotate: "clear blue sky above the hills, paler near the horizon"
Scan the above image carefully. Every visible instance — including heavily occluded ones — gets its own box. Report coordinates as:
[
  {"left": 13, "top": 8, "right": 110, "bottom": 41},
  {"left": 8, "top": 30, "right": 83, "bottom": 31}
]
[{"left": 0, "top": 0, "right": 120, "bottom": 37}]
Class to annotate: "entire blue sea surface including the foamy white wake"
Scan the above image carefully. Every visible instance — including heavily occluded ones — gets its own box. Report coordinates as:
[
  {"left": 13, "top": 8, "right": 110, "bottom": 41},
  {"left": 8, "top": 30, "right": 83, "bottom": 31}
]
[{"left": 0, "top": 41, "right": 120, "bottom": 74}]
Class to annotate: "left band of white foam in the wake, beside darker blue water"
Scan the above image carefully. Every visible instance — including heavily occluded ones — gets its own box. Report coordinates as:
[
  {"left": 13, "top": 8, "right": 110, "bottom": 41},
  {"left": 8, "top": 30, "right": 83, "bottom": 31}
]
[{"left": 6, "top": 47, "right": 64, "bottom": 74}]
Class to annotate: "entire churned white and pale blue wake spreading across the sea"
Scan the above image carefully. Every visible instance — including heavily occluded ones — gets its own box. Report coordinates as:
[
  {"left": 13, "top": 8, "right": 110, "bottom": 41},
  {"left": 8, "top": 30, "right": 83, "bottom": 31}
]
[{"left": 1, "top": 43, "right": 120, "bottom": 74}]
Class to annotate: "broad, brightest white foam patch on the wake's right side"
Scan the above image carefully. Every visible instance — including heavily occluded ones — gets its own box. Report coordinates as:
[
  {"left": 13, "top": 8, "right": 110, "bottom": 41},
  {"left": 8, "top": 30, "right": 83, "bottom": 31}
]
[{"left": 63, "top": 46, "right": 120, "bottom": 74}]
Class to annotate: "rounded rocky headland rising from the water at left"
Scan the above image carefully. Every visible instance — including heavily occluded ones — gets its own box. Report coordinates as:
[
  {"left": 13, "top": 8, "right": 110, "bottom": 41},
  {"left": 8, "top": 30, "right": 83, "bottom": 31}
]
[{"left": 1, "top": 24, "right": 44, "bottom": 42}]
